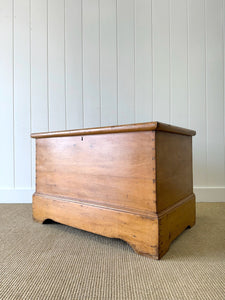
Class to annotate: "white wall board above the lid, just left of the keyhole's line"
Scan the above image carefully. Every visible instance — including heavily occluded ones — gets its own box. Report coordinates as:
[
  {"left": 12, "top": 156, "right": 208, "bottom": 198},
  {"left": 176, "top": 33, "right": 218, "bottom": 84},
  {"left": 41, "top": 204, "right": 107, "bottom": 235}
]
[{"left": 65, "top": 0, "right": 83, "bottom": 129}]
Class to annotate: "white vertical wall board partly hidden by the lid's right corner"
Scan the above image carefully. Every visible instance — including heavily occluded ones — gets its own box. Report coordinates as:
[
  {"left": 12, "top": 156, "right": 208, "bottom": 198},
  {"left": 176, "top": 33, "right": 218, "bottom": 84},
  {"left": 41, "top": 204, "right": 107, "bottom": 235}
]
[{"left": 188, "top": 0, "right": 207, "bottom": 186}]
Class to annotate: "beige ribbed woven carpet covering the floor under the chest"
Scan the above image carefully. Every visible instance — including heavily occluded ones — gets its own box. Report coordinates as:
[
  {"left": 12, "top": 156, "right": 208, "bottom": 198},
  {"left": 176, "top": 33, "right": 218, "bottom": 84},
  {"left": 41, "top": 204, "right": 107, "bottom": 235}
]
[{"left": 0, "top": 203, "right": 225, "bottom": 300}]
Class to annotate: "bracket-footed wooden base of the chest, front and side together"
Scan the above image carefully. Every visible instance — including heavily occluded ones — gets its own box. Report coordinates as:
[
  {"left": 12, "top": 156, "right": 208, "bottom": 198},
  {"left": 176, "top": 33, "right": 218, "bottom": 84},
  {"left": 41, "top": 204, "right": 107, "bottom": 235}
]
[{"left": 32, "top": 194, "right": 195, "bottom": 259}]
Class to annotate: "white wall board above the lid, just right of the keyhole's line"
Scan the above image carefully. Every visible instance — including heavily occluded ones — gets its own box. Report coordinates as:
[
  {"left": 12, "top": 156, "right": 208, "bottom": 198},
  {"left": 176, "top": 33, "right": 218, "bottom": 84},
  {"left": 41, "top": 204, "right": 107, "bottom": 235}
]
[{"left": 82, "top": 0, "right": 101, "bottom": 127}]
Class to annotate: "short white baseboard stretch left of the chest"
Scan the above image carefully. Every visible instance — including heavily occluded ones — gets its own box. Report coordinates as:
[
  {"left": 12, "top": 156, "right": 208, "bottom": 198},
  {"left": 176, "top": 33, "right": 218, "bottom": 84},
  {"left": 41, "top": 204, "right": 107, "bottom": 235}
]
[{"left": 0, "top": 189, "right": 34, "bottom": 203}]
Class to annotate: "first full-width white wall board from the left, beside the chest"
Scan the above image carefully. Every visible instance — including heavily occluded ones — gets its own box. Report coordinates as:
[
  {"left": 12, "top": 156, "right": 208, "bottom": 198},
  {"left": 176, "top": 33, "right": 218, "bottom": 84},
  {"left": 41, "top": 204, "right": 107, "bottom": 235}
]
[{"left": 13, "top": 0, "right": 32, "bottom": 188}]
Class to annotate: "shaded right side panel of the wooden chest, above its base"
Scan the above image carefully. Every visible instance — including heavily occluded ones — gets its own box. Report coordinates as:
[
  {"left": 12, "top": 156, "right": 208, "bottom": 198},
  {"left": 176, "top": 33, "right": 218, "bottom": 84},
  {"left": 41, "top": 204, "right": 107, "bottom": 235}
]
[{"left": 156, "top": 131, "right": 193, "bottom": 212}]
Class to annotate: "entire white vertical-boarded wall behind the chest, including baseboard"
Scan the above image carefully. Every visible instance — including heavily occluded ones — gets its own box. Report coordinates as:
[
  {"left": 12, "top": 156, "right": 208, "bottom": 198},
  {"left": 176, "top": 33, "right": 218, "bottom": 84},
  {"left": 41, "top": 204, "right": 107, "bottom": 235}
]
[{"left": 0, "top": 0, "right": 225, "bottom": 202}]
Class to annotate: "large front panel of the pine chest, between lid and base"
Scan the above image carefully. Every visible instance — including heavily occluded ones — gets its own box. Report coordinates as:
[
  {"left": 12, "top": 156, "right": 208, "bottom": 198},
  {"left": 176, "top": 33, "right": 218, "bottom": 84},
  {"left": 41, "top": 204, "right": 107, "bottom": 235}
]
[{"left": 36, "top": 131, "right": 156, "bottom": 212}]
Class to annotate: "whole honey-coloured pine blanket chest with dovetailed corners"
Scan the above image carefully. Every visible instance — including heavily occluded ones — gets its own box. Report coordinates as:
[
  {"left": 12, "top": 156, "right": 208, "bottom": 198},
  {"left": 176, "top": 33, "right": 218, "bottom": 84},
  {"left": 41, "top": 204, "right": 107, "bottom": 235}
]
[{"left": 31, "top": 122, "right": 195, "bottom": 259}]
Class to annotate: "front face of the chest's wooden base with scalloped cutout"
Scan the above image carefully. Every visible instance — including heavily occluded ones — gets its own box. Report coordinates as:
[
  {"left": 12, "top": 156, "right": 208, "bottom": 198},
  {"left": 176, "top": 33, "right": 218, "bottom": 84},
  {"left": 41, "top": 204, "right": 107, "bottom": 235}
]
[{"left": 33, "top": 195, "right": 158, "bottom": 259}]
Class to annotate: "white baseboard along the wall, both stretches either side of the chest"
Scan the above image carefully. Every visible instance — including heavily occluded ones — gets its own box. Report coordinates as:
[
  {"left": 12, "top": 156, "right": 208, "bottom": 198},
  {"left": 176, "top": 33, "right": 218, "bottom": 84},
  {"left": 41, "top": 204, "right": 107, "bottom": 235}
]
[{"left": 0, "top": 187, "right": 225, "bottom": 203}]
